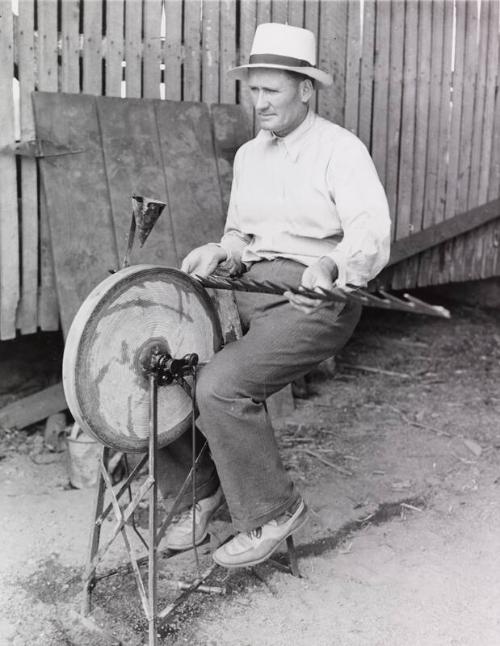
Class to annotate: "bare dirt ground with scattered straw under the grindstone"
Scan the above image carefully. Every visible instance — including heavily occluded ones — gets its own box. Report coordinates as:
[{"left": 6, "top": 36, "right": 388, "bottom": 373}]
[{"left": 0, "top": 306, "right": 500, "bottom": 646}]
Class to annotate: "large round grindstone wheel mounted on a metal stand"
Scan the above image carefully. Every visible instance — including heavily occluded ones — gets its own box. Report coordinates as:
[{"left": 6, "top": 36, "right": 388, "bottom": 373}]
[{"left": 63, "top": 265, "right": 222, "bottom": 452}]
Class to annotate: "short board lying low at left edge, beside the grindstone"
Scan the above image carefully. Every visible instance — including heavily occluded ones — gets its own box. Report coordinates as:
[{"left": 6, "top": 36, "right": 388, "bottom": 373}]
[{"left": 0, "top": 383, "right": 68, "bottom": 429}]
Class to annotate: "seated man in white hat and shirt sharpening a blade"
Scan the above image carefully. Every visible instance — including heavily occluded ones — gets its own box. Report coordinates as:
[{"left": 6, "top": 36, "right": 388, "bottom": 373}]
[{"left": 159, "top": 23, "right": 390, "bottom": 567}]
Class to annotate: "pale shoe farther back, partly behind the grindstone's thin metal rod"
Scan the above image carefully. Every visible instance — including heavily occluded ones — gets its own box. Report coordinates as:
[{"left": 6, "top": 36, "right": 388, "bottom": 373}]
[{"left": 164, "top": 487, "right": 224, "bottom": 550}]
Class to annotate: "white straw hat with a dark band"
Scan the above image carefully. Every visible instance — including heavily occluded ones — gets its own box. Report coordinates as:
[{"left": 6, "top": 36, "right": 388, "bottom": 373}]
[{"left": 228, "top": 22, "right": 333, "bottom": 87}]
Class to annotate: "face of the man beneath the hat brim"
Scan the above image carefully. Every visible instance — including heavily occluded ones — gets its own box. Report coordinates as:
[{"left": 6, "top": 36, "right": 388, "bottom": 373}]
[{"left": 248, "top": 68, "right": 310, "bottom": 137}]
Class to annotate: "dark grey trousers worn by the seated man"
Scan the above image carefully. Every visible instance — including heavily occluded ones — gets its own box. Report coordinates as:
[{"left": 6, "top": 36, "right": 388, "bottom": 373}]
[{"left": 159, "top": 259, "right": 361, "bottom": 531}]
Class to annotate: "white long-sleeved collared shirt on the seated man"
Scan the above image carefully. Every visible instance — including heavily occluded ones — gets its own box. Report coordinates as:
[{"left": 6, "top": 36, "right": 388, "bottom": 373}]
[{"left": 220, "top": 111, "right": 390, "bottom": 286}]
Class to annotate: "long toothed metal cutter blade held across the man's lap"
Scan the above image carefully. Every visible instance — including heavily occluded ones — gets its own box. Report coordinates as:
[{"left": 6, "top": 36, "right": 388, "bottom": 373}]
[{"left": 195, "top": 275, "right": 450, "bottom": 318}]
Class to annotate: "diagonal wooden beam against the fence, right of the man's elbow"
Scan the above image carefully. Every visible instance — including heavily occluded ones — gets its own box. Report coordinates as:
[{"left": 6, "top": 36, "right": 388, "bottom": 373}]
[{"left": 389, "top": 198, "right": 500, "bottom": 265}]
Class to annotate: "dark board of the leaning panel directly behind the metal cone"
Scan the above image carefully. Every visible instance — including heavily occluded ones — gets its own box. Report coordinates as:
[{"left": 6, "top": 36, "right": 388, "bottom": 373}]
[{"left": 97, "top": 97, "right": 178, "bottom": 267}]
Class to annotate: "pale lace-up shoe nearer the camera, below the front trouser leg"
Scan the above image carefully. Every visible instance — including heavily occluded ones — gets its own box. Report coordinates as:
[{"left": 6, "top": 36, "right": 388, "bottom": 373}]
[{"left": 212, "top": 500, "right": 307, "bottom": 568}]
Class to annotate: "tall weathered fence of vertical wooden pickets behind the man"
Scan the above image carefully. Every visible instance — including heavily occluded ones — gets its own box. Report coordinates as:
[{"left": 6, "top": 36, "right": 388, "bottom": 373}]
[{"left": 0, "top": 0, "right": 500, "bottom": 339}]
